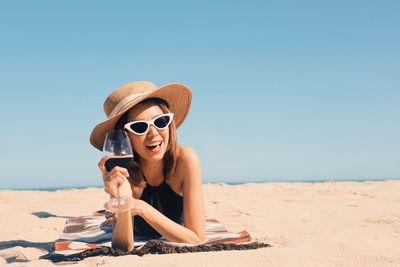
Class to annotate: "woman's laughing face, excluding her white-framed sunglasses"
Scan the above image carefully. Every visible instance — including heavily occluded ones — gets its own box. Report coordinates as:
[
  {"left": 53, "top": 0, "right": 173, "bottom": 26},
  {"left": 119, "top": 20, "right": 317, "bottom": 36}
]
[{"left": 128, "top": 103, "right": 169, "bottom": 161}]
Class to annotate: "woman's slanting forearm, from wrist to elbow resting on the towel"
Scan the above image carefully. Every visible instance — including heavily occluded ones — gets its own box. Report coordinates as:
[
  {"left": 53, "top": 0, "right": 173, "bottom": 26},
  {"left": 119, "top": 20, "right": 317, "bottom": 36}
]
[{"left": 140, "top": 205, "right": 204, "bottom": 244}]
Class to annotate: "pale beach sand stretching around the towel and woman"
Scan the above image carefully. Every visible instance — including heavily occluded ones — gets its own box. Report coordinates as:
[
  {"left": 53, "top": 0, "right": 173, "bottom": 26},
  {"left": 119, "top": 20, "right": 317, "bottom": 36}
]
[{"left": 0, "top": 180, "right": 400, "bottom": 267}]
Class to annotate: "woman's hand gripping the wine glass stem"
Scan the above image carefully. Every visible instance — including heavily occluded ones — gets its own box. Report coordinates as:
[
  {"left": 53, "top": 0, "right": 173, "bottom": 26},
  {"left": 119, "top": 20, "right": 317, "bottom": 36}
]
[{"left": 98, "top": 156, "right": 132, "bottom": 199}]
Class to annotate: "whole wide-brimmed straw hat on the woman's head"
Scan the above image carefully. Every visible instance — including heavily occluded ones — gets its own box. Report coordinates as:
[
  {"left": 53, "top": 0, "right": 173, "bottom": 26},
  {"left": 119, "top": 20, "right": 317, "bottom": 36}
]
[{"left": 90, "top": 81, "right": 192, "bottom": 150}]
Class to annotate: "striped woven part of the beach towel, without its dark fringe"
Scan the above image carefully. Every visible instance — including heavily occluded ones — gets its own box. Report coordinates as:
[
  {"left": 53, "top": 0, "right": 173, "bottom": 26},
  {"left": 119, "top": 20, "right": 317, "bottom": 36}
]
[{"left": 43, "top": 210, "right": 268, "bottom": 261}]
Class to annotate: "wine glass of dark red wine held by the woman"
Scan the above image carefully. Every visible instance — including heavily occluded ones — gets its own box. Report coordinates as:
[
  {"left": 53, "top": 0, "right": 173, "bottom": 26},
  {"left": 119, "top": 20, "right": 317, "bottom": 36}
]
[{"left": 103, "top": 129, "right": 133, "bottom": 212}]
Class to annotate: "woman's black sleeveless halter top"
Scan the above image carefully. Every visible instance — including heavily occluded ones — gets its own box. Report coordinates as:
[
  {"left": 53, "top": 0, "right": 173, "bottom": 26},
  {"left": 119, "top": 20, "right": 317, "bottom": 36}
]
[{"left": 134, "top": 178, "right": 183, "bottom": 237}]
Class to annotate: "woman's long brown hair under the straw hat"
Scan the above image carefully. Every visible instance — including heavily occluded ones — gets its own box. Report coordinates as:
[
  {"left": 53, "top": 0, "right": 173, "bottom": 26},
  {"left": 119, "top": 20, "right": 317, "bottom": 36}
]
[{"left": 114, "top": 98, "right": 178, "bottom": 198}]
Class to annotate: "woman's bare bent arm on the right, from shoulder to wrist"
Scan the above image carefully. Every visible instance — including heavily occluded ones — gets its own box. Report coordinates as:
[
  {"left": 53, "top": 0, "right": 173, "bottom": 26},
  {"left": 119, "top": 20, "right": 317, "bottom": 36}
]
[{"left": 140, "top": 147, "right": 205, "bottom": 244}]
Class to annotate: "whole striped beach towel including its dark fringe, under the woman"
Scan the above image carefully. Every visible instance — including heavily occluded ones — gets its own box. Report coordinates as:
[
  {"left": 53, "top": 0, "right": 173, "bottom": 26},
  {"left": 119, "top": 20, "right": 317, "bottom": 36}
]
[{"left": 41, "top": 210, "right": 270, "bottom": 262}]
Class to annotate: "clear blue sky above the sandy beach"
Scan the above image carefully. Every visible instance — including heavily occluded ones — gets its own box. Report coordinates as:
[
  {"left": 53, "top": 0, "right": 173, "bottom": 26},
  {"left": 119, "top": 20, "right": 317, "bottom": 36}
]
[{"left": 0, "top": 0, "right": 400, "bottom": 188}]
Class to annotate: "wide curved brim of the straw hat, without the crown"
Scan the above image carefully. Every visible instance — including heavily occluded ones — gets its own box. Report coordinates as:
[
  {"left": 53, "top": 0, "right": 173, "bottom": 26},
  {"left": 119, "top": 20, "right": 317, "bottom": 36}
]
[{"left": 90, "top": 83, "right": 192, "bottom": 151}]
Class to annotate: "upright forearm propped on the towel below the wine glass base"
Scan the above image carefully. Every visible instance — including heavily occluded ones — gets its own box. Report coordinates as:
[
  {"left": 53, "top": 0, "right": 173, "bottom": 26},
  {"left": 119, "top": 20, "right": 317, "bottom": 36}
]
[{"left": 112, "top": 209, "right": 134, "bottom": 251}]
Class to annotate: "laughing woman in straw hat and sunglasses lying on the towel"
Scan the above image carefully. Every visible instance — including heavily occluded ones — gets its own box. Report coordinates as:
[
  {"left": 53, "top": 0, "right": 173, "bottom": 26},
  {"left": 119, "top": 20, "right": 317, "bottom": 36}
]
[{"left": 90, "top": 82, "right": 205, "bottom": 251}]
